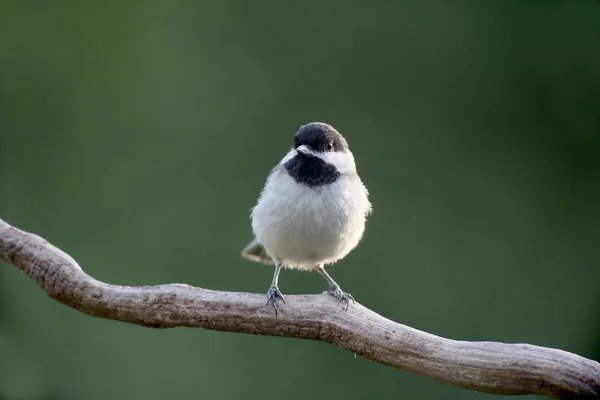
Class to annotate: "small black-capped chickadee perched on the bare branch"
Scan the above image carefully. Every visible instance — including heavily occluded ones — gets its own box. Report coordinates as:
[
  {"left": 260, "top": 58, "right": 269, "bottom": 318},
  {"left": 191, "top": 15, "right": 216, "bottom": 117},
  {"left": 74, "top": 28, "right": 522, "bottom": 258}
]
[{"left": 242, "top": 122, "right": 371, "bottom": 313}]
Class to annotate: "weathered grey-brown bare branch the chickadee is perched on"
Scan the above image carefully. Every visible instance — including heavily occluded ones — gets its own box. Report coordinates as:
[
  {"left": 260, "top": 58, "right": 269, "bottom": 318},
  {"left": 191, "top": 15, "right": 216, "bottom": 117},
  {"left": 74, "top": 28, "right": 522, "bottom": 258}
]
[{"left": 0, "top": 220, "right": 600, "bottom": 398}]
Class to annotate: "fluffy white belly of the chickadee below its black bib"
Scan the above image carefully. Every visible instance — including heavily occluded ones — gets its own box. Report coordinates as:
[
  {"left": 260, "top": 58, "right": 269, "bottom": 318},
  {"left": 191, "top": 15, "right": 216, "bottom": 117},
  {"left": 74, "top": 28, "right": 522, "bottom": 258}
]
[{"left": 252, "top": 169, "right": 370, "bottom": 269}]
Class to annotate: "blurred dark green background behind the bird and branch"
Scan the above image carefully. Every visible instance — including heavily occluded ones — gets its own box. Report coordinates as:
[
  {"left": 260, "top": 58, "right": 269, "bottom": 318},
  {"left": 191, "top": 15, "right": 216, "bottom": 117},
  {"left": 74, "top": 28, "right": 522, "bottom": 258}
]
[{"left": 0, "top": 0, "right": 600, "bottom": 400}]
